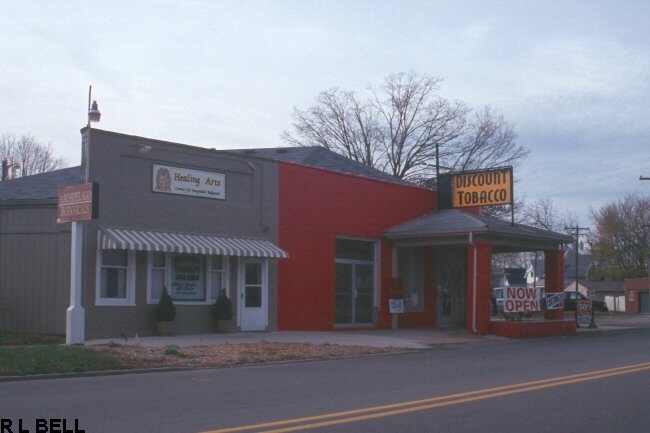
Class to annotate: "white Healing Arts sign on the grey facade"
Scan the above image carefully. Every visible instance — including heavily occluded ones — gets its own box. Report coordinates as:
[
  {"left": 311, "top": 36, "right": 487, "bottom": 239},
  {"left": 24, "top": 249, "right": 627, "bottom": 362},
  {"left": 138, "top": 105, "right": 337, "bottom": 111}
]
[{"left": 152, "top": 164, "right": 226, "bottom": 200}]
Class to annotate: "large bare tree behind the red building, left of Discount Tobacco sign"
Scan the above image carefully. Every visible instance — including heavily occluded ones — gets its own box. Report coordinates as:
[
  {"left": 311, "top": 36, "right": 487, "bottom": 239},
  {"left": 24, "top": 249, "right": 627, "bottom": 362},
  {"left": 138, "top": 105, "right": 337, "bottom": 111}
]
[{"left": 282, "top": 72, "right": 468, "bottom": 181}]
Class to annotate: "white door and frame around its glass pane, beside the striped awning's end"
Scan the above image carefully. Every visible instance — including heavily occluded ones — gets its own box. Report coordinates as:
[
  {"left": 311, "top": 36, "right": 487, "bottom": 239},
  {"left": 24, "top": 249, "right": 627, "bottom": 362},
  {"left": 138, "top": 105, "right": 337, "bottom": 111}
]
[{"left": 237, "top": 257, "right": 269, "bottom": 331}]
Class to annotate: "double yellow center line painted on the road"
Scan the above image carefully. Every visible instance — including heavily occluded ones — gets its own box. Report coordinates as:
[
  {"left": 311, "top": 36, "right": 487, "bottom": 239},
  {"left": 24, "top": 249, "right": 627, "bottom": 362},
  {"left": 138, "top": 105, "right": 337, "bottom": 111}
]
[{"left": 199, "top": 362, "right": 650, "bottom": 433}]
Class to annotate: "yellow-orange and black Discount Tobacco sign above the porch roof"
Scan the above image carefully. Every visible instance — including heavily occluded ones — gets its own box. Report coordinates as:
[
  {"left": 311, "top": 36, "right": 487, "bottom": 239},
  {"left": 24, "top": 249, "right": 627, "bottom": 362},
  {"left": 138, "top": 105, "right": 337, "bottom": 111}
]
[{"left": 451, "top": 167, "right": 512, "bottom": 207}]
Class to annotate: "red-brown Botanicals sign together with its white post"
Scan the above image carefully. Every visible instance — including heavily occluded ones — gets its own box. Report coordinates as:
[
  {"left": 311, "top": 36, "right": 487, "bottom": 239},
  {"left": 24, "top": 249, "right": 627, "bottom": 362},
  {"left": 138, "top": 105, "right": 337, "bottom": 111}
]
[{"left": 56, "top": 183, "right": 99, "bottom": 344}]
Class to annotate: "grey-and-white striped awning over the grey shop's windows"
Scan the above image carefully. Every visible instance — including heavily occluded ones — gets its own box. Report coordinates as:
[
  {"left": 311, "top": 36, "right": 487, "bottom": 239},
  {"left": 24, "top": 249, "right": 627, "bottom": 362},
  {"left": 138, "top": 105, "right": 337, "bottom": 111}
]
[{"left": 99, "top": 227, "right": 289, "bottom": 259}]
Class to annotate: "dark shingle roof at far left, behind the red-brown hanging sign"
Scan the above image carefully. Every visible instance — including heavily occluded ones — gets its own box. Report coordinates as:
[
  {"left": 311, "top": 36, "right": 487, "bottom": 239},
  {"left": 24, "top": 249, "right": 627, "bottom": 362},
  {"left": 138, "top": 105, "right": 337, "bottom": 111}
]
[{"left": 0, "top": 166, "right": 83, "bottom": 201}]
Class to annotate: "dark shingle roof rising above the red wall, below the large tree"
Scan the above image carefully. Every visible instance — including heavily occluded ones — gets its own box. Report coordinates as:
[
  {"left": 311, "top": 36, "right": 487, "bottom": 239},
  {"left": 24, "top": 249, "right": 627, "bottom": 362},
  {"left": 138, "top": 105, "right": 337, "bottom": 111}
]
[{"left": 226, "top": 146, "right": 413, "bottom": 186}]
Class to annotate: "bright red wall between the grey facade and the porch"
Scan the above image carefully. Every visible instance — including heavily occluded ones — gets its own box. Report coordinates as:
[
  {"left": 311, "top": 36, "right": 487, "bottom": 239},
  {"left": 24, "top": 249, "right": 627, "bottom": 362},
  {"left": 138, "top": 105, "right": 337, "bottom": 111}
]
[{"left": 278, "top": 163, "right": 436, "bottom": 330}]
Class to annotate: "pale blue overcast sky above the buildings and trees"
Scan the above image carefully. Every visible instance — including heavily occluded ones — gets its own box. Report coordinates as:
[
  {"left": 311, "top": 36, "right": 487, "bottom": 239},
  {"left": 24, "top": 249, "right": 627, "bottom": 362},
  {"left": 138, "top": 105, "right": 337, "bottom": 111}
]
[{"left": 0, "top": 0, "right": 650, "bottom": 225}]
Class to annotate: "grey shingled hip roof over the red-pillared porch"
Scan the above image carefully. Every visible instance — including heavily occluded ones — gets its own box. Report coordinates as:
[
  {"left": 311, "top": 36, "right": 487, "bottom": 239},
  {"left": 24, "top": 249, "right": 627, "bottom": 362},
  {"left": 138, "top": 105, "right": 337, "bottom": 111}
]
[{"left": 384, "top": 209, "right": 573, "bottom": 253}]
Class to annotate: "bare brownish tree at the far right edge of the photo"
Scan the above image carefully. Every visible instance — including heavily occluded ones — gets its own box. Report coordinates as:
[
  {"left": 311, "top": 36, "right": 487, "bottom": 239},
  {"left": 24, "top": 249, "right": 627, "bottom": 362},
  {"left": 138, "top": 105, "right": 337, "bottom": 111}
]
[{"left": 588, "top": 194, "right": 650, "bottom": 281}]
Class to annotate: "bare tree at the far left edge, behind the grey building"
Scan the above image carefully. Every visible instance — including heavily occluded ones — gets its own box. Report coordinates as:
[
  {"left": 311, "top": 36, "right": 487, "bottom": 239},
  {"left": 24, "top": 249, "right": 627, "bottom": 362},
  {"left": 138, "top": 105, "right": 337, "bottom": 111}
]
[{"left": 0, "top": 134, "right": 67, "bottom": 176}]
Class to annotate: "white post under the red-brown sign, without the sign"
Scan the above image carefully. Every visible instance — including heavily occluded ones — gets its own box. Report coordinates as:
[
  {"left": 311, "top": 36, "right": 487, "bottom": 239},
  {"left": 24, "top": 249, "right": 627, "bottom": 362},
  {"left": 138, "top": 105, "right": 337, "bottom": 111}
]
[{"left": 65, "top": 221, "right": 85, "bottom": 344}]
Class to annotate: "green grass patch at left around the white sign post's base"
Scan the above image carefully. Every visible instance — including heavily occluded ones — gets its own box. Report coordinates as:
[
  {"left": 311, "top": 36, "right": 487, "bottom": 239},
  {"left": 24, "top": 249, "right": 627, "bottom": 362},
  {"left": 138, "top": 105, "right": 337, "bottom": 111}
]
[{"left": 0, "top": 333, "right": 131, "bottom": 376}]
